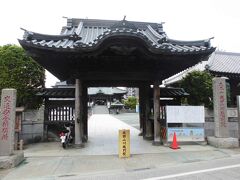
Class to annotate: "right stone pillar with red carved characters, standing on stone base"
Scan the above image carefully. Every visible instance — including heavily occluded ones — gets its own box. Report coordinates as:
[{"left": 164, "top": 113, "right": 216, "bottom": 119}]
[{"left": 213, "top": 77, "right": 229, "bottom": 138}]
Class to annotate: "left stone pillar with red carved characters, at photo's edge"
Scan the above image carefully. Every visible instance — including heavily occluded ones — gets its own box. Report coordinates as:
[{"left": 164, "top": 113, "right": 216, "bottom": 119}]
[{"left": 0, "top": 89, "right": 17, "bottom": 156}]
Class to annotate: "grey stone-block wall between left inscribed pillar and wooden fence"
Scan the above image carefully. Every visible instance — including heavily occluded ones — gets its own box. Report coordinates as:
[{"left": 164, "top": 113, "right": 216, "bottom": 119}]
[{"left": 19, "top": 107, "right": 44, "bottom": 143}]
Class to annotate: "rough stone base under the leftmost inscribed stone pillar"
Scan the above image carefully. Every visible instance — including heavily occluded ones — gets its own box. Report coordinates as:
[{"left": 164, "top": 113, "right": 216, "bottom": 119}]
[{"left": 0, "top": 151, "right": 24, "bottom": 169}]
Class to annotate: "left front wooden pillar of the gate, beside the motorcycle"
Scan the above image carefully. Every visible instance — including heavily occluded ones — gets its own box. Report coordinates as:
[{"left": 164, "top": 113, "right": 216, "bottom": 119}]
[{"left": 75, "top": 79, "right": 83, "bottom": 147}]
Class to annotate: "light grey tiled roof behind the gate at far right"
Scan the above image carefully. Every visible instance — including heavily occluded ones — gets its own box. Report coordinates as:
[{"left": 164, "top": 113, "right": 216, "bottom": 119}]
[{"left": 163, "top": 51, "right": 240, "bottom": 85}]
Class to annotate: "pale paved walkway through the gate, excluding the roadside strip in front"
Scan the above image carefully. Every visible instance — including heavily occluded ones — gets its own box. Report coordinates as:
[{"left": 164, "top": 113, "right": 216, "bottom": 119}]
[{"left": 25, "top": 114, "right": 216, "bottom": 157}]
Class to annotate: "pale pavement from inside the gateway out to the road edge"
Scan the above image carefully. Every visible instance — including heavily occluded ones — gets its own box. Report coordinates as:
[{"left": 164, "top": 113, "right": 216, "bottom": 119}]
[{"left": 0, "top": 114, "right": 240, "bottom": 180}]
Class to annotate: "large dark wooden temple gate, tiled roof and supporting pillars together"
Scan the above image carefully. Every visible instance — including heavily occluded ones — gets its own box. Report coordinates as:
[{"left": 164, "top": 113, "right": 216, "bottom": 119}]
[{"left": 19, "top": 18, "right": 215, "bottom": 146}]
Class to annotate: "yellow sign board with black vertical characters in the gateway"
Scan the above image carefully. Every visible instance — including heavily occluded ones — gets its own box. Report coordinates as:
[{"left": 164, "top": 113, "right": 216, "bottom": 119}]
[{"left": 118, "top": 129, "right": 130, "bottom": 158}]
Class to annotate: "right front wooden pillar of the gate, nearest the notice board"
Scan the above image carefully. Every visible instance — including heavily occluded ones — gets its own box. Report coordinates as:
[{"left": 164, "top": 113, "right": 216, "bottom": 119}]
[{"left": 153, "top": 82, "right": 161, "bottom": 145}]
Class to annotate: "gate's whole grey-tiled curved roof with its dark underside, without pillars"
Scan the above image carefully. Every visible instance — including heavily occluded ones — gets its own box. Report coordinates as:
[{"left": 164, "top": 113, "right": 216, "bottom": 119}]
[{"left": 19, "top": 18, "right": 215, "bottom": 83}]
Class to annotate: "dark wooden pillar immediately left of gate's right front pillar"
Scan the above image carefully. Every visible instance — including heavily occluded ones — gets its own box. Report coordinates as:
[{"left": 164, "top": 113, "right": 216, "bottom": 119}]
[{"left": 144, "top": 85, "right": 153, "bottom": 140}]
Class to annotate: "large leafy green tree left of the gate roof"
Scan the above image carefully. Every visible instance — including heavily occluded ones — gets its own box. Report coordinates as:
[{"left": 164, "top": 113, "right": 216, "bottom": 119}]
[{"left": 0, "top": 45, "right": 45, "bottom": 108}]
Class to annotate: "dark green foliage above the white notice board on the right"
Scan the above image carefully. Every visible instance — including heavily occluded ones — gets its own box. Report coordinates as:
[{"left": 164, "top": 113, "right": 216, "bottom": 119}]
[{"left": 180, "top": 71, "right": 213, "bottom": 108}]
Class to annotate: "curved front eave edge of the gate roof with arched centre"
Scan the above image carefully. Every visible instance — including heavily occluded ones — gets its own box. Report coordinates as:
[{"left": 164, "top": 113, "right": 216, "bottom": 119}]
[{"left": 18, "top": 32, "right": 215, "bottom": 55}]
